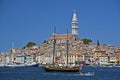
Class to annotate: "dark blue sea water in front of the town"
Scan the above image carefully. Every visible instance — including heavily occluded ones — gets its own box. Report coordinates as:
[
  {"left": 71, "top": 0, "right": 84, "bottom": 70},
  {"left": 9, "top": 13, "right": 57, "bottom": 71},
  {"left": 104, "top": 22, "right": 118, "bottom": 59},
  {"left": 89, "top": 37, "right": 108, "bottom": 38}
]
[{"left": 0, "top": 67, "right": 120, "bottom": 80}]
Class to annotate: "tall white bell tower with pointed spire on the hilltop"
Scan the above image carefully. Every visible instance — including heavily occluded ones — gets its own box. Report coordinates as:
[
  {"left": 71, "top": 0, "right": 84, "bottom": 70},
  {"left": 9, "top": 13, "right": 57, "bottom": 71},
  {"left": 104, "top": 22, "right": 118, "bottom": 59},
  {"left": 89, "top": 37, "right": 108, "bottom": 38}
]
[{"left": 72, "top": 11, "right": 78, "bottom": 35}]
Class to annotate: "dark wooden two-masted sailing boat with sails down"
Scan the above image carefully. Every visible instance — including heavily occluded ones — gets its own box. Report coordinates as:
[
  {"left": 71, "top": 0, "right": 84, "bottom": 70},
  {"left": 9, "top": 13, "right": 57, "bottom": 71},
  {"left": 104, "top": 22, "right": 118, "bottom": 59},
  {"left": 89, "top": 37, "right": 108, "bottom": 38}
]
[{"left": 44, "top": 28, "right": 80, "bottom": 72}]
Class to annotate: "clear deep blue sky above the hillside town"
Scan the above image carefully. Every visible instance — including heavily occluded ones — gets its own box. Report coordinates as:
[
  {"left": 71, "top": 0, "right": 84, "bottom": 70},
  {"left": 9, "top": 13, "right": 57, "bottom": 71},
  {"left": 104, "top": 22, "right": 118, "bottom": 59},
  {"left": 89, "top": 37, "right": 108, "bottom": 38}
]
[{"left": 0, "top": 0, "right": 120, "bottom": 52}]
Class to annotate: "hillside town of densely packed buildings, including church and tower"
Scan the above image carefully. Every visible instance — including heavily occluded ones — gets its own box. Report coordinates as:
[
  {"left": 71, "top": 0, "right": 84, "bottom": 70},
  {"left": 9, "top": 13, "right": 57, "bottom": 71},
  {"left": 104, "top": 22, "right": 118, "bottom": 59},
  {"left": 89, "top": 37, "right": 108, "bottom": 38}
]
[{"left": 0, "top": 11, "right": 120, "bottom": 65}]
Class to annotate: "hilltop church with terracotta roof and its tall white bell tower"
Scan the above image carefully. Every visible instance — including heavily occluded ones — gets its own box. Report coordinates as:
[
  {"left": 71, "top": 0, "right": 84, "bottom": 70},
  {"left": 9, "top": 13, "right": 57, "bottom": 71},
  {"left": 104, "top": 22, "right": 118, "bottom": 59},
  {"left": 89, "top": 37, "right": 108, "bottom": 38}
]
[{"left": 48, "top": 11, "right": 79, "bottom": 43}]
